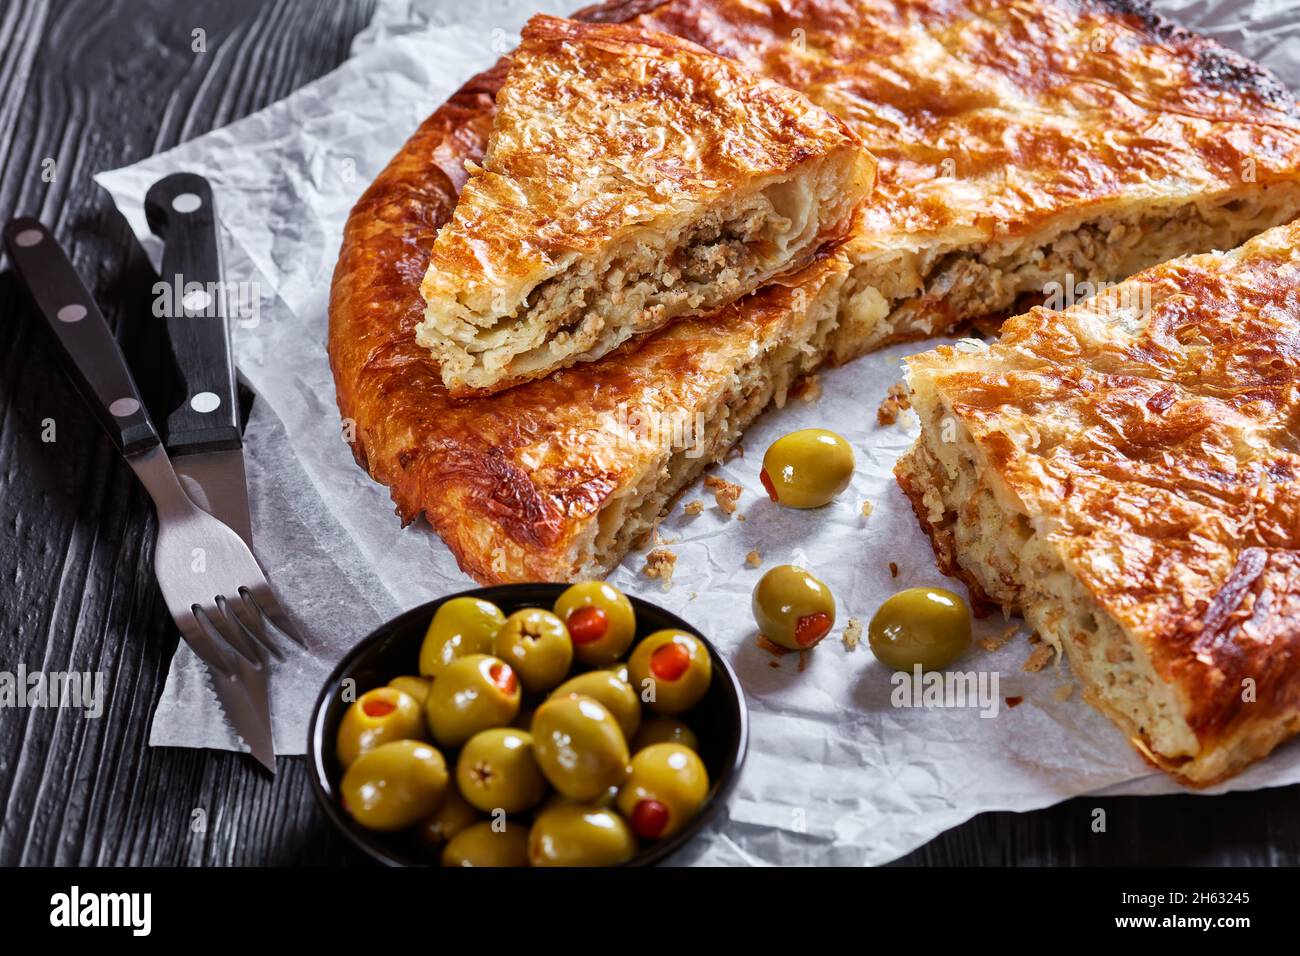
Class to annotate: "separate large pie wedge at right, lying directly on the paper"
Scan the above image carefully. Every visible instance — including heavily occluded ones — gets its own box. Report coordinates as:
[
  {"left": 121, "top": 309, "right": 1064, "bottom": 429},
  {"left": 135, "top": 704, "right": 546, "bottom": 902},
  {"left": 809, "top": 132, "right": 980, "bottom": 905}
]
[{"left": 896, "top": 221, "right": 1300, "bottom": 784}]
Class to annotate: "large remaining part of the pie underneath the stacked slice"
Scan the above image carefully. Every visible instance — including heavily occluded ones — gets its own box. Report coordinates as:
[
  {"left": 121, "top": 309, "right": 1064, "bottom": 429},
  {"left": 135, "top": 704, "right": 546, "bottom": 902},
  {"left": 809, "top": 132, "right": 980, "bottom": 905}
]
[{"left": 330, "top": 0, "right": 1300, "bottom": 581}]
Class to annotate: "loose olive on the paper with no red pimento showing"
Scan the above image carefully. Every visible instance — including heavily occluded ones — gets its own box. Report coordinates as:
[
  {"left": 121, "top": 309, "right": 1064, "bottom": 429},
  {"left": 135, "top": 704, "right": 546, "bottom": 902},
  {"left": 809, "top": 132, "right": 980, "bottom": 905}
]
[{"left": 867, "top": 588, "right": 971, "bottom": 671}]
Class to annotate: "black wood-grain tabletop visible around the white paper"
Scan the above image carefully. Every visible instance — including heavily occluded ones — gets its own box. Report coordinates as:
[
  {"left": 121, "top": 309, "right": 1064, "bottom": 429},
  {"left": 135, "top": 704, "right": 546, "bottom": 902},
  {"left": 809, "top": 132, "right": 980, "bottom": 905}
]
[{"left": 0, "top": 0, "right": 1300, "bottom": 865}]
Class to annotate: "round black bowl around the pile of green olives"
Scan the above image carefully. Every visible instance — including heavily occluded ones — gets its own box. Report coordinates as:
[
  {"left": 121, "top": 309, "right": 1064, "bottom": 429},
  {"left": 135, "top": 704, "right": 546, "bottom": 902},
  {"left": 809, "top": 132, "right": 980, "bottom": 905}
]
[{"left": 307, "top": 584, "right": 749, "bottom": 866}]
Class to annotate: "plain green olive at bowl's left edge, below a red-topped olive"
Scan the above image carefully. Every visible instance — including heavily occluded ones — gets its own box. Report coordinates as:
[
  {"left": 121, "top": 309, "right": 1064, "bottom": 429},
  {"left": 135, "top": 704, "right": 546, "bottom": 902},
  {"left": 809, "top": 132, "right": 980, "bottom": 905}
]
[{"left": 339, "top": 740, "right": 447, "bottom": 831}]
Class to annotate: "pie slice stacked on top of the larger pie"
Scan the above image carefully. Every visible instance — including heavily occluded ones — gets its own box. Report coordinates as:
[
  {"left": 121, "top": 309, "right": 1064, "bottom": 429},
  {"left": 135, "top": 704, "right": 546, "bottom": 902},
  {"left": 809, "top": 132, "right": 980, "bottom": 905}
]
[{"left": 417, "top": 16, "right": 875, "bottom": 394}]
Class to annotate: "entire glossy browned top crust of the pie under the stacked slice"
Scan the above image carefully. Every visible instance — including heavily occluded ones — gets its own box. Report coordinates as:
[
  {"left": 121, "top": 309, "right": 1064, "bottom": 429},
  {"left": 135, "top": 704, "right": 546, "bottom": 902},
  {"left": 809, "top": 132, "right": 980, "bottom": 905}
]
[{"left": 330, "top": 0, "right": 1300, "bottom": 581}]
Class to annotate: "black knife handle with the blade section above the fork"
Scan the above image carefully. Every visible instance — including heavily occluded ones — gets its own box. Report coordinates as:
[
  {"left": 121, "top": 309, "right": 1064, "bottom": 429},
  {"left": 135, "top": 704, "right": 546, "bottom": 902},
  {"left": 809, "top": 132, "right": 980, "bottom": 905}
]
[{"left": 144, "top": 173, "right": 252, "bottom": 548}]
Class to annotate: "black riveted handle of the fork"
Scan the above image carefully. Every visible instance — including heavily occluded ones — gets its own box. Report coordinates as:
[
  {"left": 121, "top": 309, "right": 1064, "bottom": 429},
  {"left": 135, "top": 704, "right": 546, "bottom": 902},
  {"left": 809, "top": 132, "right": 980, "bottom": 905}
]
[{"left": 4, "top": 216, "right": 160, "bottom": 455}]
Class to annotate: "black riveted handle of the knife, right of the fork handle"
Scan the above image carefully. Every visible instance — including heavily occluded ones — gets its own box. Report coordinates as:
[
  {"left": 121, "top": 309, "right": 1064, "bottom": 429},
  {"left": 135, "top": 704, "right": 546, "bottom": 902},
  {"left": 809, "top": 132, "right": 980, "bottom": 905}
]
[{"left": 144, "top": 173, "right": 242, "bottom": 455}]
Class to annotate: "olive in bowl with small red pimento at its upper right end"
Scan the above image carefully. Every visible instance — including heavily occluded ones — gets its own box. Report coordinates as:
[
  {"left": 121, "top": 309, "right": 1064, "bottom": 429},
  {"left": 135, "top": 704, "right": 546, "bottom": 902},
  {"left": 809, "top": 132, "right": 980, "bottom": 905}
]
[{"left": 424, "top": 654, "right": 520, "bottom": 747}]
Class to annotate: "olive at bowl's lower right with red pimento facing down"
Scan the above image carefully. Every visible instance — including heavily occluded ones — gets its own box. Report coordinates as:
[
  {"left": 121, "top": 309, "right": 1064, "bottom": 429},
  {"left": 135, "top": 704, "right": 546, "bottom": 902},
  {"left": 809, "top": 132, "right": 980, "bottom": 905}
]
[{"left": 618, "top": 744, "right": 709, "bottom": 840}]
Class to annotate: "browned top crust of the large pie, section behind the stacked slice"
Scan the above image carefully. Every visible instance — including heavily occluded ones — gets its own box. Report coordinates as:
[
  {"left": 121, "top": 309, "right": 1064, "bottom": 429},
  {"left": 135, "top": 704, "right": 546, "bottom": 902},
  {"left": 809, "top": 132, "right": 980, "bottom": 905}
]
[{"left": 638, "top": 0, "right": 1300, "bottom": 247}]
